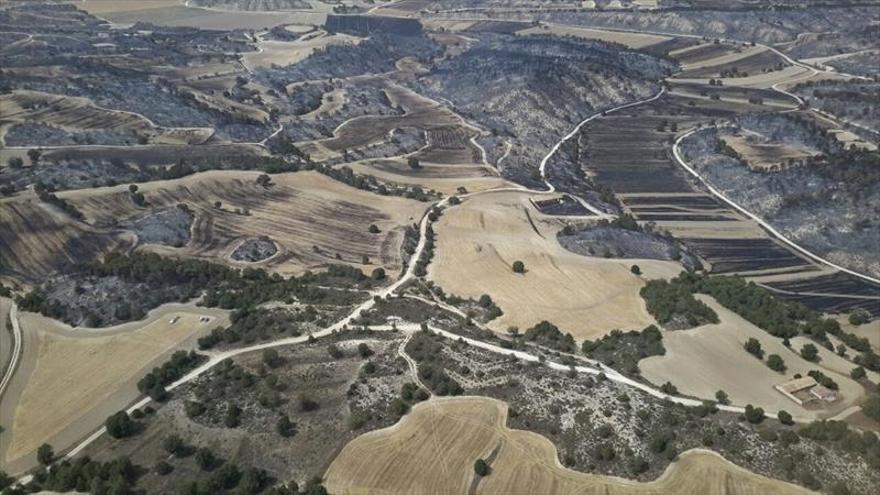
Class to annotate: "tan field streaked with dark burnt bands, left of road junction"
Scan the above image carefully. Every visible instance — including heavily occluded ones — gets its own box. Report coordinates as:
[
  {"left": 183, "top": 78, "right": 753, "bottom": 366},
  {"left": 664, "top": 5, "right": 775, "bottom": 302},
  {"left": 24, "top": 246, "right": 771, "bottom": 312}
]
[{"left": 63, "top": 171, "right": 425, "bottom": 275}]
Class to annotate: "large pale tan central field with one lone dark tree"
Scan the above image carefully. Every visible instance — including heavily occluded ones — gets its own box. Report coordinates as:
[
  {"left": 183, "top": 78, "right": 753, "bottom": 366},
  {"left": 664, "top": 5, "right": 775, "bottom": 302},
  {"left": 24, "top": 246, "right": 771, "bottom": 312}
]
[{"left": 430, "top": 192, "right": 681, "bottom": 340}]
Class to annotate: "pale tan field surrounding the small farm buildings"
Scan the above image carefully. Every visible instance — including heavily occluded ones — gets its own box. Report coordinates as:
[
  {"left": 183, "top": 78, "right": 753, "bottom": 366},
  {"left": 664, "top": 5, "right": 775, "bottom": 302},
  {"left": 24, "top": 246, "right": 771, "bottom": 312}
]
[{"left": 639, "top": 295, "right": 864, "bottom": 418}]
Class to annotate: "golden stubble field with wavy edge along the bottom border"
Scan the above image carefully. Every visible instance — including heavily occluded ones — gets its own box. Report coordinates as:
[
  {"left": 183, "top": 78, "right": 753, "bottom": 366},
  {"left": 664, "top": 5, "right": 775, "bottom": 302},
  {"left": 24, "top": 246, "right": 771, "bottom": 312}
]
[{"left": 326, "top": 397, "right": 810, "bottom": 495}]
